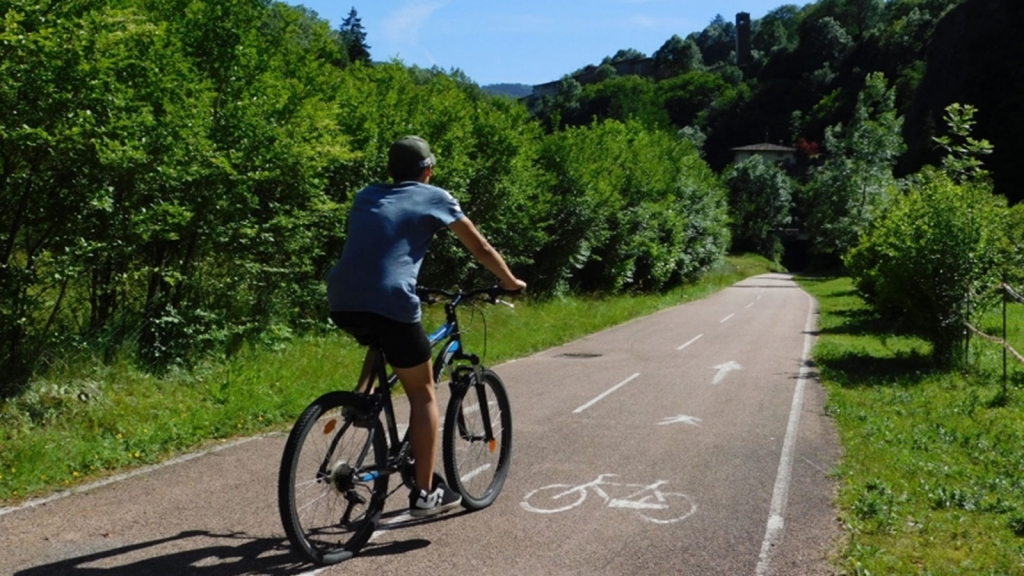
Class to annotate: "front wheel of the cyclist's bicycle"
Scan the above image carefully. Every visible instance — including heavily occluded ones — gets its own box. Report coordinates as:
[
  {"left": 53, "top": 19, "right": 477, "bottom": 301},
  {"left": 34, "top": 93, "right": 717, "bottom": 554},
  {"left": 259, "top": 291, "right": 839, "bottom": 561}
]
[{"left": 441, "top": 368, "right": 512, "bottom": 510}]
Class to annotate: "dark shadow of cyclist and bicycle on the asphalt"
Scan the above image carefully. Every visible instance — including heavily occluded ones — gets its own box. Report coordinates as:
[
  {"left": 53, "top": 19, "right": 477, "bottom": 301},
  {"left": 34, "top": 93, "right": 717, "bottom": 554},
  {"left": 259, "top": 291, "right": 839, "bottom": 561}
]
[{"left": 14, "top": 530, "right": 430, "bottom": 576}]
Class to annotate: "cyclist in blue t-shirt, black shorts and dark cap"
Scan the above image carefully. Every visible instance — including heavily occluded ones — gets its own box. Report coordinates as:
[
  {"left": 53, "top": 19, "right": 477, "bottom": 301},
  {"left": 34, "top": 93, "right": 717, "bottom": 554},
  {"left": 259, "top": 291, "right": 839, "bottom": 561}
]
[{"left": 328, "top": 136, "right": 526, "bottom": 518}]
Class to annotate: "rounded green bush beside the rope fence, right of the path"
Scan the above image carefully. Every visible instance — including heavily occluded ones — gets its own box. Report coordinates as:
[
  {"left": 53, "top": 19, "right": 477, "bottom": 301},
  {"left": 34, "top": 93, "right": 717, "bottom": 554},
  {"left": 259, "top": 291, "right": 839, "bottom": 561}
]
[{"left": 847, "top": 106, "right": 1021, "bottom": 364}]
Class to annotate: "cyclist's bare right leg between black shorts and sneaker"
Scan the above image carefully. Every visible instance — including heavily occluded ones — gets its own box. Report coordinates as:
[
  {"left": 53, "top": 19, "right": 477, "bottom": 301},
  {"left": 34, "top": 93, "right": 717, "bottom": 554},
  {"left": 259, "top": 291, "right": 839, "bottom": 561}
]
[{"left": 394, "top": 360, "right": 440, "bottom": 492}]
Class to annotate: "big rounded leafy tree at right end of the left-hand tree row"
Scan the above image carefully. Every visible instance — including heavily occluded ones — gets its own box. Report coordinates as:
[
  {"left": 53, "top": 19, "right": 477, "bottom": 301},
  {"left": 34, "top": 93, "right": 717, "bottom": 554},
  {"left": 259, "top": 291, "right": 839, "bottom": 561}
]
[{"left": 530, "top": 121, "right": 728, "bottom": 293}]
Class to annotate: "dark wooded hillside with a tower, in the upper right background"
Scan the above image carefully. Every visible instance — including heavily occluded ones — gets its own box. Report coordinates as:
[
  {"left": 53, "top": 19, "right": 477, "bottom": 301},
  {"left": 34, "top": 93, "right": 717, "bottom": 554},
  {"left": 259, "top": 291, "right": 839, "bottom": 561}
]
[{"left": 531, "top": 0, "right": 1024, "bottom": 203}]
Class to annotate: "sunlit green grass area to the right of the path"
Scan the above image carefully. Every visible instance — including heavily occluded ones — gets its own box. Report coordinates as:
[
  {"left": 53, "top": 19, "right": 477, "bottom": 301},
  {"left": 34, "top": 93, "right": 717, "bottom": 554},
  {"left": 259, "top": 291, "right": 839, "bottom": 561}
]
[{"left": 800, "top": 278, "right": 1024, "bottom": 575}]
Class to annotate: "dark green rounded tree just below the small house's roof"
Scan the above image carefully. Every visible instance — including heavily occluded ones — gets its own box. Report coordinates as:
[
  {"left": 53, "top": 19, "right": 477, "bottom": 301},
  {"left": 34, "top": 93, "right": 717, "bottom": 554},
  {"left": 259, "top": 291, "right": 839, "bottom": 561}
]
[{"left": 725, "top": 156, "right": 793, "bottom": 261}]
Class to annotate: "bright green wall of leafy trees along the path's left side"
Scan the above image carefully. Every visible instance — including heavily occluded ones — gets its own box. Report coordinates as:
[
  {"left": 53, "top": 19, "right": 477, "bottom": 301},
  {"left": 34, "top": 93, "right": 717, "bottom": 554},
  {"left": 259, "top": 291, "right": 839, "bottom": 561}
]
[{"left": 0, "top": 0, "right": 727, "bottom": 397}]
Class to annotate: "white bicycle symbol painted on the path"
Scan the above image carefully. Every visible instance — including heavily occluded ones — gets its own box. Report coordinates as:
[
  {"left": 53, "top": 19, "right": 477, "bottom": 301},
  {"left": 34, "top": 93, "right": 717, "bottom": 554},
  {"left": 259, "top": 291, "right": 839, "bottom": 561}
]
[{"left": 519, "top": 474, "right": 697, "bottom": 524}]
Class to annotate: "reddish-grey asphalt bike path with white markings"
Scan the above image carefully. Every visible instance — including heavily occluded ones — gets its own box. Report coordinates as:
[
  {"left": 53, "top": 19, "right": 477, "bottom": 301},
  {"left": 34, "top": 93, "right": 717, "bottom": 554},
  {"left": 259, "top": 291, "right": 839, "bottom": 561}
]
[{"left": 0, "top": 275, "right": 839, "bottom": 576}]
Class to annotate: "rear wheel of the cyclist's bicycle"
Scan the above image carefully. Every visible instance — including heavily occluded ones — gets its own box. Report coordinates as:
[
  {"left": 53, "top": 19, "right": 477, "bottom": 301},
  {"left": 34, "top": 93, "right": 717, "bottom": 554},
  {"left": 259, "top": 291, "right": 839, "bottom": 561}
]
[{"left": 278, "top": 392, "right": 388, "bottom": 565}]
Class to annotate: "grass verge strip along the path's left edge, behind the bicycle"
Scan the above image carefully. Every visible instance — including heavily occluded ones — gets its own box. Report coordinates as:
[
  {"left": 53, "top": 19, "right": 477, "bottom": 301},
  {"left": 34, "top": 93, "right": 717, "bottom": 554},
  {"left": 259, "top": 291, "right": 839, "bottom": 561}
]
[{"left": 0, "top": 253, "right": 771, "bottom": 504}]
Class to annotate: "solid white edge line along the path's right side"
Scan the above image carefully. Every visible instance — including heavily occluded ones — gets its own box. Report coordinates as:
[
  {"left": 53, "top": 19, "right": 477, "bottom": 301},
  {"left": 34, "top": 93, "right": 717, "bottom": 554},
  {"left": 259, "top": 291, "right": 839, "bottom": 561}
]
[{"left": 754, "top": 294, "right": 814, "bottom": 576}]
